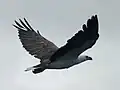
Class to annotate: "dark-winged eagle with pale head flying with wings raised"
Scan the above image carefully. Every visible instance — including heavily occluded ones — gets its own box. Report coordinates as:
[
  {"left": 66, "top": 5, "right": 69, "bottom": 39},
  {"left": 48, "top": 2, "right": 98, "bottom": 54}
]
[{"left": 13, "top": 15, "right": 99, "bottom": 74}]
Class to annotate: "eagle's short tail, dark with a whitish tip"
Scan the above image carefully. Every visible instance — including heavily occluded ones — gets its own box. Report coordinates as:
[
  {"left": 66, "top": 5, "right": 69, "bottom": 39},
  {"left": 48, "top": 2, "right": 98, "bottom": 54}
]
[{"left": 25, "top": 64, "right": 46, "bottom": 74}]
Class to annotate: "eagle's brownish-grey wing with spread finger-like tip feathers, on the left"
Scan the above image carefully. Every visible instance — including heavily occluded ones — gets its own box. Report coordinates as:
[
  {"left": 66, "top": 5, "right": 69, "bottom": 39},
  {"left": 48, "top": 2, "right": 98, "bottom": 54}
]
[{"left": 13, "top": 18, "right": 58, "bottom": 61}]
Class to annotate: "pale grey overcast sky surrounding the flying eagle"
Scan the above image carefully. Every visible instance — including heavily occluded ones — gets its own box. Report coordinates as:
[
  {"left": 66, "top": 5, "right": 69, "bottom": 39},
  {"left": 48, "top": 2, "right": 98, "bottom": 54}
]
[{"left": 0, "top": 0, "right": 120, "bottom": 90}]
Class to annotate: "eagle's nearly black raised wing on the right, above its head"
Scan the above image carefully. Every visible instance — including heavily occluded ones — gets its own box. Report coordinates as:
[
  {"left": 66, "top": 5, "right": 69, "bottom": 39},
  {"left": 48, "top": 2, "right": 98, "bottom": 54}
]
[{"left": 50, "top": 15, "right": 99, "bottom": 61}]
